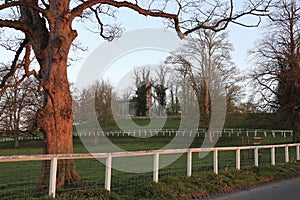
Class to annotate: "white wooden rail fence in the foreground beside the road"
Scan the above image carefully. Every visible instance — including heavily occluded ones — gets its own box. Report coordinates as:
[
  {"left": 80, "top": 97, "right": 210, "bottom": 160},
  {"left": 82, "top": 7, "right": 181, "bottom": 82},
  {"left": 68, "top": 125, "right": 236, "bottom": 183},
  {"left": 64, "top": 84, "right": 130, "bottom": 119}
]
[{"left": 0, "top": 143, "right": 300, "bottom": 197}]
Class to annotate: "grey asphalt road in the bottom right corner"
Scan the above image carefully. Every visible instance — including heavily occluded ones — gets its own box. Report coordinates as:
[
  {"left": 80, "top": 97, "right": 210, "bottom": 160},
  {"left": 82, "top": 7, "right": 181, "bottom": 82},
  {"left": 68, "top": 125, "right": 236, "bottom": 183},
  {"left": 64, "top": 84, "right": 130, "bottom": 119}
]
[{"left": 210, "top": 178, "right": 300, "bottom": 200}]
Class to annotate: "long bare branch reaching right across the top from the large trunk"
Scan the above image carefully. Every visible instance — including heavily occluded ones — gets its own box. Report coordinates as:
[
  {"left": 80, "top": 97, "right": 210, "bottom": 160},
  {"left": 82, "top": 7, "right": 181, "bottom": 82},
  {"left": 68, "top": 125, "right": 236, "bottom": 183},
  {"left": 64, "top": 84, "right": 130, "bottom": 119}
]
[{"left": 71, "top": 0, "right": 271, "bottom": 38}]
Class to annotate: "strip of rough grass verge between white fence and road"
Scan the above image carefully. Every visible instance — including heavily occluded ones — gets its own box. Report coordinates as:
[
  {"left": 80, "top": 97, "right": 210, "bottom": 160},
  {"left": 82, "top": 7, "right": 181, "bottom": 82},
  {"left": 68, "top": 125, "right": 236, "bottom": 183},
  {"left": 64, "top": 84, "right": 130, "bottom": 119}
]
[{"left": 30, "top": 162, "right": 300, "bottom": 200}]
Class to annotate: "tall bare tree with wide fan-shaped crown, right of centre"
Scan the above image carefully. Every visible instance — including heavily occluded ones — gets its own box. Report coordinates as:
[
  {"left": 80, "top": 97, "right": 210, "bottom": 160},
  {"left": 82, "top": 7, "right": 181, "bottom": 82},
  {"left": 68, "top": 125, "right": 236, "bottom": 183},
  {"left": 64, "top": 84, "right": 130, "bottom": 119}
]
[{"left": 166, "top": 30, "right": 237, "bottom": 142}]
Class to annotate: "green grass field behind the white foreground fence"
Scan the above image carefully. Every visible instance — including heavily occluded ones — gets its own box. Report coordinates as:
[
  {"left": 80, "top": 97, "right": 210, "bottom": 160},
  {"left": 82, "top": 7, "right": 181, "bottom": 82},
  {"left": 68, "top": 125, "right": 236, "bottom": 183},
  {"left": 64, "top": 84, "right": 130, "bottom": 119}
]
[{"left": 0, "top": 115, "right": 296, "bottom": 199}]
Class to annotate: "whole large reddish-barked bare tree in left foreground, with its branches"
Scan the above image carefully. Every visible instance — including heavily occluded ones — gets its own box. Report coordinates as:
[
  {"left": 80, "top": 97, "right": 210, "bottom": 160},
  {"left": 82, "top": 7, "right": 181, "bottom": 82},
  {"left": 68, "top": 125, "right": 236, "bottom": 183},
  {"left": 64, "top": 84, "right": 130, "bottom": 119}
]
[{"left": 0, "top": 0, "right": 269, "bottom": 189}]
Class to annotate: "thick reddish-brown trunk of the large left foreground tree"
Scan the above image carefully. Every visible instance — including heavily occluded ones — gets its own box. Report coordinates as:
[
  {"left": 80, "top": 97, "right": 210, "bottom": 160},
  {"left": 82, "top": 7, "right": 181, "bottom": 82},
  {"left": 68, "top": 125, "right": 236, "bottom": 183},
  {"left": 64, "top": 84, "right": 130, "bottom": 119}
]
[{"left": 23, "top": 1, "right": 80, "bottom": 190}]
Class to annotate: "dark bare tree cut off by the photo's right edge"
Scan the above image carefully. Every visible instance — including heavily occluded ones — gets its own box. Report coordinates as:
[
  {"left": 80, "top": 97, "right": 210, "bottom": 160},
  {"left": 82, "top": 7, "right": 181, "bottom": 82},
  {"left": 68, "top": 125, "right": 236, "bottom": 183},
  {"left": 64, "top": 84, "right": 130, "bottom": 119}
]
[{"left": 252, "top": 0, "right": 300, "bottom": 142}]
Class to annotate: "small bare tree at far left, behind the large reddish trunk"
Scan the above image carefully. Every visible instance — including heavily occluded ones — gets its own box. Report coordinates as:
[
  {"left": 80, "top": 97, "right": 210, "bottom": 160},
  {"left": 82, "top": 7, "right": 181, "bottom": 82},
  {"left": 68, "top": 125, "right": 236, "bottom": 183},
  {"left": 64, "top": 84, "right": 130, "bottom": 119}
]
[{"left": 0, "top": 66, "right": 42, "bottom": 148}]
